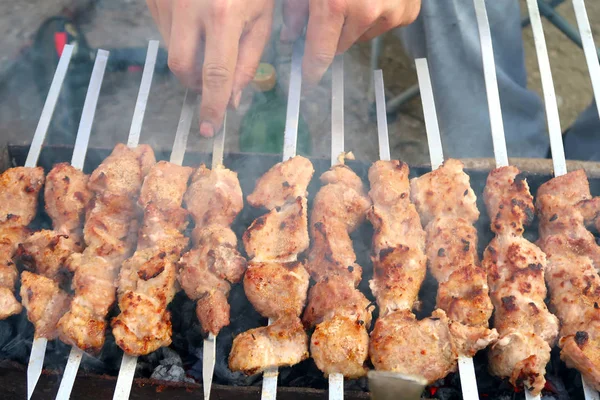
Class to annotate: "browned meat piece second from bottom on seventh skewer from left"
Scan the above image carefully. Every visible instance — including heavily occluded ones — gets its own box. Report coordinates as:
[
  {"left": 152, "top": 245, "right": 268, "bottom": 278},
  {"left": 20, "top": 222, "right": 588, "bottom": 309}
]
[{"left": 302, "top": 276, "right": 373, "bottom": 328}]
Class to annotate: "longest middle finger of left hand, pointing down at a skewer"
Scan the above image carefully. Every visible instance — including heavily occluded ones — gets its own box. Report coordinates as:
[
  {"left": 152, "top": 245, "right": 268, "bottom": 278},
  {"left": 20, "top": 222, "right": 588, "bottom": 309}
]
[{"left": 200, "top": 11, "right": 242, "bottom": 137}]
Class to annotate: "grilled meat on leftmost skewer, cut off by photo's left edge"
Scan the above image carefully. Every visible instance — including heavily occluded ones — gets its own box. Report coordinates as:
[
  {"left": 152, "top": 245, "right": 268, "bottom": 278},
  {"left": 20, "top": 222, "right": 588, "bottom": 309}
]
[{"left": 0, "top": 167, "right": 44, "bottom": 320}]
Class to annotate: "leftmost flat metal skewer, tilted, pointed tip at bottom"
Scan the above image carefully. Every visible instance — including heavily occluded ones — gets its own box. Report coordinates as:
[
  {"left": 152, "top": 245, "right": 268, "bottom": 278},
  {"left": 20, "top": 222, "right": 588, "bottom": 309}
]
[{"left": 25, "top": 44, "right": 73, "bottom": 399}]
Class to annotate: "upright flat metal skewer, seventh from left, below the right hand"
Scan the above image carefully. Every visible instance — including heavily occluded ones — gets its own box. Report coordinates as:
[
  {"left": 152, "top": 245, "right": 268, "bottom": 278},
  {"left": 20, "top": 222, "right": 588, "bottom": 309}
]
[{"left": 329, "top": 55, "right": 344, "bottom": 400}]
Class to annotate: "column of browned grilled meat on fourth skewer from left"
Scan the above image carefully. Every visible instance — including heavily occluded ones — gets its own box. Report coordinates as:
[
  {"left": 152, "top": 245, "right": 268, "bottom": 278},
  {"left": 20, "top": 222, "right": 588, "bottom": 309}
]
[{"left": 111, "top": 161, "right": 192, "bottom": 356}]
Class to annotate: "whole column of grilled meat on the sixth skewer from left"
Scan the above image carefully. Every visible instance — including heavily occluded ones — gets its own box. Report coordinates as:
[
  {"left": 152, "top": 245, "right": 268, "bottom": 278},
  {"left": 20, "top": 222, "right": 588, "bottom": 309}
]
[{"left": 229, "top": 156, "right": 314, "bottom": 374}]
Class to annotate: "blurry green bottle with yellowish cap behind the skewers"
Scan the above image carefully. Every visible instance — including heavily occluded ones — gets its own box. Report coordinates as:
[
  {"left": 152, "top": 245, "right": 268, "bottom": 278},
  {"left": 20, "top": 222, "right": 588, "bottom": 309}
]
[{"left": 240, "top": 63, "right": 311, "bottom": 156}]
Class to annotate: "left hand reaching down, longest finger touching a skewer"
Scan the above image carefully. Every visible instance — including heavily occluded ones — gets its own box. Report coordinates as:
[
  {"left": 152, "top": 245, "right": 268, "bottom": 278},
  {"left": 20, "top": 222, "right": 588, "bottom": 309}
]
[{"left": 147, "top": 0, "right": 274, "bottom": 137}]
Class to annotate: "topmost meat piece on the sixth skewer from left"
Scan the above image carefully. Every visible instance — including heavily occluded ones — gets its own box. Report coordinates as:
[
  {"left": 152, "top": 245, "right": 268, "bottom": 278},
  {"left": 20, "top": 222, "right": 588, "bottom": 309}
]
[{"left": 247, "top": 156, "right": 315, "bottom": 210}]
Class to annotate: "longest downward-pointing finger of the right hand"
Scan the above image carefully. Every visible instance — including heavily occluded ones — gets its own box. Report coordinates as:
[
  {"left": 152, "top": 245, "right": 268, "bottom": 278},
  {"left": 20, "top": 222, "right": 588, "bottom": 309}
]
[{"left": 302, "top": 0, "right": 345, "bottom": 84}]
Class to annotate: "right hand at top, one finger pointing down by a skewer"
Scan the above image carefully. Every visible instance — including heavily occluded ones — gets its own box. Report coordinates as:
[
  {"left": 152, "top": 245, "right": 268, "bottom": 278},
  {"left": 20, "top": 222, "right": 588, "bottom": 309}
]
[{"left": 281, "top": 0, "right": 421, "bottom": 84}]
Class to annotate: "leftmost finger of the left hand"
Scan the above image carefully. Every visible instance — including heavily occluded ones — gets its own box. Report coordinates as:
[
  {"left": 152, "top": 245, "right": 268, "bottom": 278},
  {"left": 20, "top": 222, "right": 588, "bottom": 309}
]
[{"left": 168, "top": 2, "right": 202, "bottom": 91}]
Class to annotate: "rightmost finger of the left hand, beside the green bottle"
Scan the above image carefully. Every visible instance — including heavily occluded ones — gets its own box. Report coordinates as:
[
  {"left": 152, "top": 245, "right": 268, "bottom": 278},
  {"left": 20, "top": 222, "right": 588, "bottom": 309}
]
[{"left": 231, "top": 13, "right": 272, "bottom": 108}]
